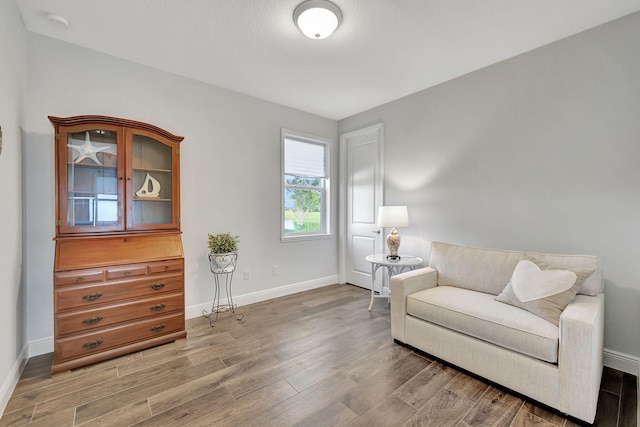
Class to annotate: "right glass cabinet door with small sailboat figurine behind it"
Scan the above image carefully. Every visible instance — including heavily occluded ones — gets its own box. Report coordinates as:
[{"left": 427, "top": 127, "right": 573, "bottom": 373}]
[{"left": 126, "top": 130, "right": 179, "bottom": 230}]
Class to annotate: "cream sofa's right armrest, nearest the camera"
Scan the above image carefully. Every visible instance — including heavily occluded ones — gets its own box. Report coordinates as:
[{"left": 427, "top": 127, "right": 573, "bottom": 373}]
[{"left": 558, "top": 293, "right": 604, "bottom": 420}]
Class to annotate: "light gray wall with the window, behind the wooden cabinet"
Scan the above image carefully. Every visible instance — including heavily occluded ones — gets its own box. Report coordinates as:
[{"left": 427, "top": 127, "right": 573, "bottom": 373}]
[{"left": 25, "top": 33, "right": 338, "bottom": 348}]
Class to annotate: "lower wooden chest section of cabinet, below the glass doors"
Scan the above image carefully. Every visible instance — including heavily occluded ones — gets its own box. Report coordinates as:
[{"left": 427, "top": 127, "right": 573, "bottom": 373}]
[{"left": 51, "top": 231, "right": 187, "bottom": 374}]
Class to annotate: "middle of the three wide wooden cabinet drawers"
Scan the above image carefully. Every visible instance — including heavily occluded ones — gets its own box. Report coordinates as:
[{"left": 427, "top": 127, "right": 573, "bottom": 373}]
[{"left": 56, "top": 292, "right": 184, "bottom": 336}]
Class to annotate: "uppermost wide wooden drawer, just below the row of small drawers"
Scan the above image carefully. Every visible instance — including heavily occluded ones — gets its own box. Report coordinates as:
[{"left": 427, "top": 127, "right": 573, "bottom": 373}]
[{"left": 54, "top": 274, "right": 183, "bottom": 313}]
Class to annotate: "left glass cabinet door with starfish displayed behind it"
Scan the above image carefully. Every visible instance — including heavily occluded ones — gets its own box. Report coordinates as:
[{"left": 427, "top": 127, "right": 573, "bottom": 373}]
[{"left": 58, "top": 126, "right": 124, "bottom": 233}]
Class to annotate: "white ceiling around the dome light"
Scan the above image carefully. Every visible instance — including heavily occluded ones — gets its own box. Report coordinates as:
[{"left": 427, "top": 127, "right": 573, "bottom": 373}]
[{"left": 13, "top": 0, "right": 640, "bottom": 120}]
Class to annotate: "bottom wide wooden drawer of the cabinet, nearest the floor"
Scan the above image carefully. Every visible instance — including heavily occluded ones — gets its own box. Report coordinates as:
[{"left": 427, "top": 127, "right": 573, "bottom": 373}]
[{"left": 55, "top": 311, "right": 184, "bottom": 361}]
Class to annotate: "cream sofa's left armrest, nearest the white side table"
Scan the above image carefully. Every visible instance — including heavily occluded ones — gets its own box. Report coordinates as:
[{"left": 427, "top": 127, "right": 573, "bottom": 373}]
[{"left": 391, "top": 267, "right": 438, "bottom": 342}]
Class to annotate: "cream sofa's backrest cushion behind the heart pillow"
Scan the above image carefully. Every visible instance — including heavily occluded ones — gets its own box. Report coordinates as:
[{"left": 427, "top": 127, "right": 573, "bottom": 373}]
[{"left": 429, "top": 242, "right": 604, "bottom": 295}]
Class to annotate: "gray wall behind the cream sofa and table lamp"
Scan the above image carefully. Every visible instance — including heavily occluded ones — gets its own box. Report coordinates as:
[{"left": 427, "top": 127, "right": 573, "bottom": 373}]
[{"left": 339, "top": 13, "right": 640, "bottom": 357}]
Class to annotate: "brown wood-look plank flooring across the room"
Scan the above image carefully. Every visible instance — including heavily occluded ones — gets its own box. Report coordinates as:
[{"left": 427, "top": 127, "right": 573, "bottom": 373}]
[{"left": 0, "top": 285, "right": 637, "bottom": 427}]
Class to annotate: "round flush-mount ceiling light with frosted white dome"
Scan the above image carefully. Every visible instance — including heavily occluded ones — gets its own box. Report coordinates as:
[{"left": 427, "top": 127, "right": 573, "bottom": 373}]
[{"left": 293, "top": 0, "right": 342, "bottom": 40}]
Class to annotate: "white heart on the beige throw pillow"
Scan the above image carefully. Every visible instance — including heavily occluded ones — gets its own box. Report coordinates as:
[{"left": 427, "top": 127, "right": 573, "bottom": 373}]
[{"left": 511, "top": 260, "right": 578, "bottom": 302}]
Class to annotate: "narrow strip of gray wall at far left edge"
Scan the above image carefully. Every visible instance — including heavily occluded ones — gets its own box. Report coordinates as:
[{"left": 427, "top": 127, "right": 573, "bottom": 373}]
[{"left": 0, "top": 1, "right": 27, "bottom": 413}]
